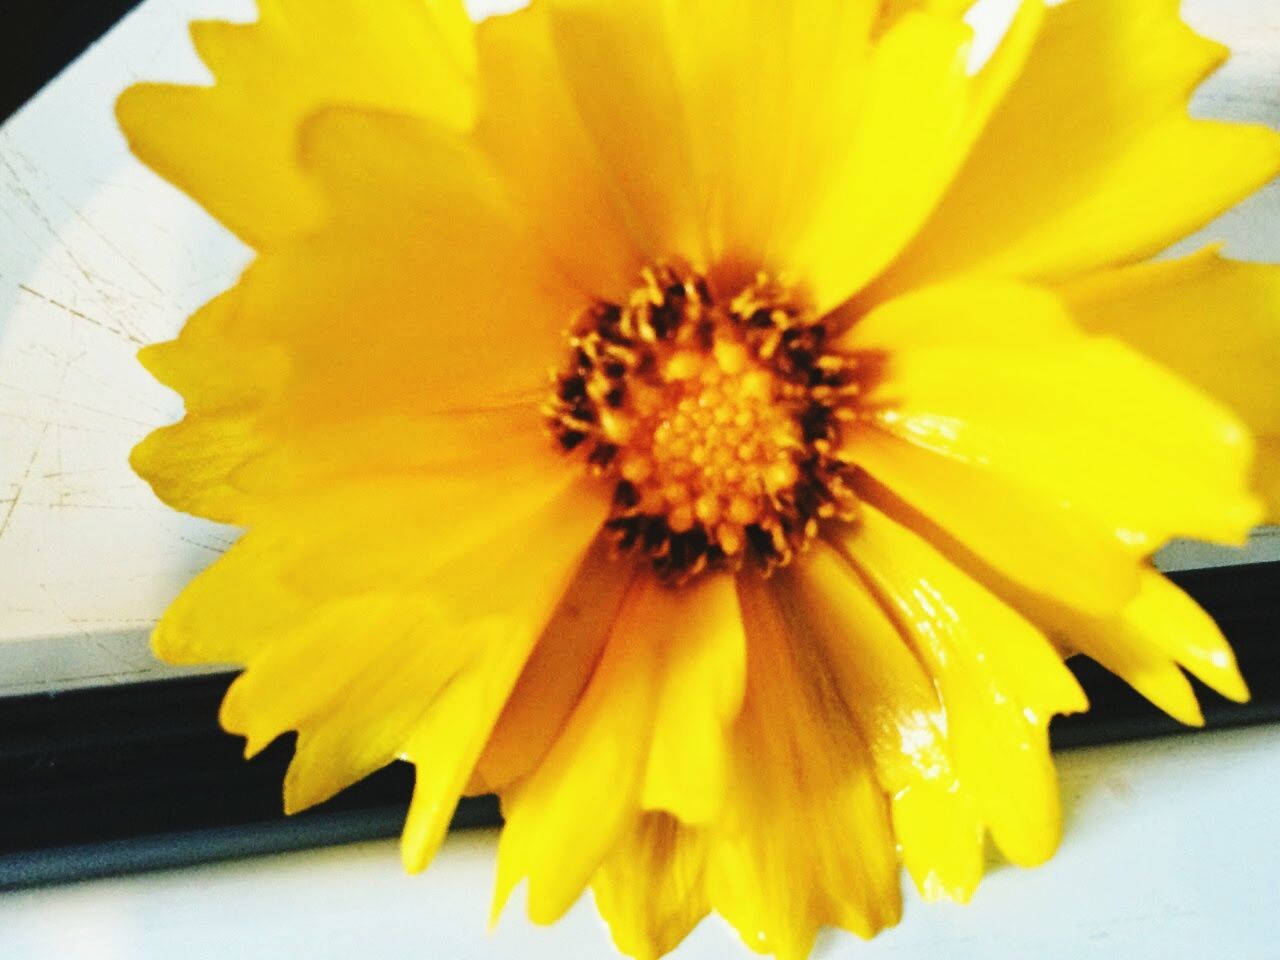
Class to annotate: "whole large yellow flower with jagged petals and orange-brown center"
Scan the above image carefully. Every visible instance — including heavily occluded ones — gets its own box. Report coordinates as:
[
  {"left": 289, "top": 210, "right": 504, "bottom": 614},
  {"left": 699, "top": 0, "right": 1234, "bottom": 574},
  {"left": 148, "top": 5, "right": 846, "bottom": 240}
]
[{"left": 119, "top": 0, "right": 1280, "bottom": 957}]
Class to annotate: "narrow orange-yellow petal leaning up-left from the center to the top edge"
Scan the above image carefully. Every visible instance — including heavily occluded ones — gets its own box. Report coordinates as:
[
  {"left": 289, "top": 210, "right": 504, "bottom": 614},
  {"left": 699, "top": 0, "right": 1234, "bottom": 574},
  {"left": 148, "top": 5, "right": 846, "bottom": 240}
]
[{"left": 475, "top": 3, "right": 645, "bottom": 303}]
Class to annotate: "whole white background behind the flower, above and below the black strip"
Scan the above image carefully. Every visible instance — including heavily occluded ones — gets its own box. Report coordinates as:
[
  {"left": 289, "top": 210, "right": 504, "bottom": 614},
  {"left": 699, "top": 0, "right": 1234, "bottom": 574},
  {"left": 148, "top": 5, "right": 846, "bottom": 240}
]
[{"left": 0, "top": 0, "right": 1280, "bottom": 960}]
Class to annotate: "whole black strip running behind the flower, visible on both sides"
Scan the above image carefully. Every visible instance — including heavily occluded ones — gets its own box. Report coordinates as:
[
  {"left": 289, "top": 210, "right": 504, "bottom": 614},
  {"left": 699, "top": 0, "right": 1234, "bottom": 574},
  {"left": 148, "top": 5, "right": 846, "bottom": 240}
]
[{"left": 0, "top": 563, "right": 1280, "bottom": 888}]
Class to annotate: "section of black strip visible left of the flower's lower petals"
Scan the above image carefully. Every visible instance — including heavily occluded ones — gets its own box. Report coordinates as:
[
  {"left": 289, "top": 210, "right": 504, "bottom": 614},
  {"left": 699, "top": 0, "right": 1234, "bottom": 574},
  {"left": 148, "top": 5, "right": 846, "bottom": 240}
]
[{"left": 0, "top": 675, "right": 500, "bottom": 890}]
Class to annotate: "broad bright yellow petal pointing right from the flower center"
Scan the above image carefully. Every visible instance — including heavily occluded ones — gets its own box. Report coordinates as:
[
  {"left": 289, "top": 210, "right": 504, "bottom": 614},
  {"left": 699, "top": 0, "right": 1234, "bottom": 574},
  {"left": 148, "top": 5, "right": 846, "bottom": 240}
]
[{"left": 867, "top": 337, "right": 1258, "bottom": 556}]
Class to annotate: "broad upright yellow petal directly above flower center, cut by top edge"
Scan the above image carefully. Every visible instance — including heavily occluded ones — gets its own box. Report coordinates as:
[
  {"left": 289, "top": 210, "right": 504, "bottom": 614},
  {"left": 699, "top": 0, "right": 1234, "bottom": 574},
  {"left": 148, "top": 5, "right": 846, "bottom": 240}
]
[{"left": 649, "top": 0, "right": 876, "bottom": 288}]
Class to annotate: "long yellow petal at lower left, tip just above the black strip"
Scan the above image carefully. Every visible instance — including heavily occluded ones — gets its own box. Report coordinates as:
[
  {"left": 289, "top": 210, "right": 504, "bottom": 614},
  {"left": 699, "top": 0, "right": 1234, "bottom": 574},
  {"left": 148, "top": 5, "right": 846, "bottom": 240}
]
[{"left": 154, "top": 445, "right": 583, "bottom": 663}]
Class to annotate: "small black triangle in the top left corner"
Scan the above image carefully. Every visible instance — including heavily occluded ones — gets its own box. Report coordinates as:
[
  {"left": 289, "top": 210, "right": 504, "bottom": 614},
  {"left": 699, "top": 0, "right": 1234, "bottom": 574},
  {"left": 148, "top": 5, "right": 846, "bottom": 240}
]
[{"left": 0, "top": 0, "right": 138, "bottom": 122}]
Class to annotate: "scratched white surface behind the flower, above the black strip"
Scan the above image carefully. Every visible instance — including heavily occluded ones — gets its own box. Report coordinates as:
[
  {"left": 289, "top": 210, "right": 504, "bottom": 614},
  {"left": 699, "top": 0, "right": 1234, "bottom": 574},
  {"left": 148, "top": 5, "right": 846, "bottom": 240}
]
[{"left": 0, "top": 0, "right": 1280, "bottom": 692}]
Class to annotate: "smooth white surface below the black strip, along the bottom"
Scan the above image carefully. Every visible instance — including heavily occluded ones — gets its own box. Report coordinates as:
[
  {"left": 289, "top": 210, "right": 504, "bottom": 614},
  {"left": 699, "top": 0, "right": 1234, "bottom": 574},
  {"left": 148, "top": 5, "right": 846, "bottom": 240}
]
[{"left": 0, "top": 727, "right": 1280, "bottom": 960}]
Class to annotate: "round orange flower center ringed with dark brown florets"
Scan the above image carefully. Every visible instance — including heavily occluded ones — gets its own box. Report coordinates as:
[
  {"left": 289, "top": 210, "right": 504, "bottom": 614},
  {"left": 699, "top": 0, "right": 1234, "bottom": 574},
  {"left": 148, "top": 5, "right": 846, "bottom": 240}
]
[{"left": 545, "top": 264, "right": 858, "bottom": 584}]
